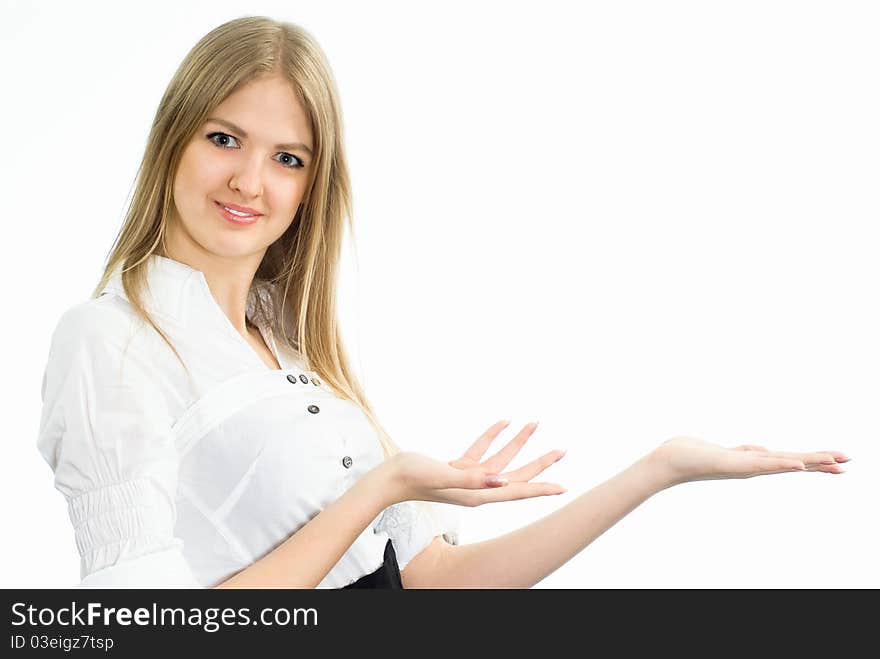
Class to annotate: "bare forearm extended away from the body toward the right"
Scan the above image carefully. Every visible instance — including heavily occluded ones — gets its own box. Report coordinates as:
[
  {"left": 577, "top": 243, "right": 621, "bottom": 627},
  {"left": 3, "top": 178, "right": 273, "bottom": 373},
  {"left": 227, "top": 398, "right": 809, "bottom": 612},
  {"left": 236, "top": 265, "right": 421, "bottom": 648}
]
[{"left": 430, "top": 455, "right": 672, "bottom": 588}]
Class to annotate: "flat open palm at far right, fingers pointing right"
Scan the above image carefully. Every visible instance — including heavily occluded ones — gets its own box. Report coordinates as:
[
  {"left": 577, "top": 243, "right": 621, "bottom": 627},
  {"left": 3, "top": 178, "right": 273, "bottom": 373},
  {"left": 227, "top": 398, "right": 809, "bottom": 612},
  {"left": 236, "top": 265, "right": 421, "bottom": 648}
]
[{"left": 648, "top": 437, "right": 850, "bottom": 485}]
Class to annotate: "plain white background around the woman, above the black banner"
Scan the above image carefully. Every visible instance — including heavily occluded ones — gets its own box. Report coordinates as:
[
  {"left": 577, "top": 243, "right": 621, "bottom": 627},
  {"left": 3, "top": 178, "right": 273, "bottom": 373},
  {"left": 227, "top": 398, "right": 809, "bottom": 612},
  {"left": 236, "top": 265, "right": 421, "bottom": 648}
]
[{"left": 0, "top": 0, "right": 880, "bottom": 588}]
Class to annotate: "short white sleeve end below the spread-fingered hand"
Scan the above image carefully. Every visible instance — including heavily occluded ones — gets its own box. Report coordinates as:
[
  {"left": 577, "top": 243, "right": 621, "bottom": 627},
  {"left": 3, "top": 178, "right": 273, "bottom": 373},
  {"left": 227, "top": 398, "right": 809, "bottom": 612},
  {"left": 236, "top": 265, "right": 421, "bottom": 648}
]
[{"left": 373, "top": 501, "right": 461, "bottom": 570}]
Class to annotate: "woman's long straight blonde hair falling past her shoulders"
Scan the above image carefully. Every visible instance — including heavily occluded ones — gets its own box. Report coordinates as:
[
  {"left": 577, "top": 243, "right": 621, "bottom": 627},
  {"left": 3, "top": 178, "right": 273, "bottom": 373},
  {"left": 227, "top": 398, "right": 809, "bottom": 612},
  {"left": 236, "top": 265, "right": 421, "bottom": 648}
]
[{"left": 92, "top": 16, "right": 400, "bottom": 457}]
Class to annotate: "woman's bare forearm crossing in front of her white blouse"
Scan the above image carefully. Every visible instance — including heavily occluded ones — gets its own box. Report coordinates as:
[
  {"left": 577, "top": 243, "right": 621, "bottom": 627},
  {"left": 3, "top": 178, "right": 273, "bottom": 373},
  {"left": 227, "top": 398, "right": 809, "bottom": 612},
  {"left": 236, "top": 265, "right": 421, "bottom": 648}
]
[{"left": 214, "top": 465, "right": 394, "bottom": 588}]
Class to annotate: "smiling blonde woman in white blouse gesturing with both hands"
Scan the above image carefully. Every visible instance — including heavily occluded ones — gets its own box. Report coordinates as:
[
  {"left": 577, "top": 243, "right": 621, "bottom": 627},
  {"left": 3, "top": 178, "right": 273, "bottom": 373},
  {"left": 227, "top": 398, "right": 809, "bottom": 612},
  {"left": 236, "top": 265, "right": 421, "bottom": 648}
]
[{"left": 38, "top": 17, "right": 848, "bottom": 588}]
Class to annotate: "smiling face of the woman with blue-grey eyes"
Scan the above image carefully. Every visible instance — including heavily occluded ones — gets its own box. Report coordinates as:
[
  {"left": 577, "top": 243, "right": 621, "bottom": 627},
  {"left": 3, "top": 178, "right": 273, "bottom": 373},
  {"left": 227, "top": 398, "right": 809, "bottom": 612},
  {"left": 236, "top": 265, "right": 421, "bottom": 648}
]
[{"left": 166, "top": 77, "right": 313, "bottom": 262}]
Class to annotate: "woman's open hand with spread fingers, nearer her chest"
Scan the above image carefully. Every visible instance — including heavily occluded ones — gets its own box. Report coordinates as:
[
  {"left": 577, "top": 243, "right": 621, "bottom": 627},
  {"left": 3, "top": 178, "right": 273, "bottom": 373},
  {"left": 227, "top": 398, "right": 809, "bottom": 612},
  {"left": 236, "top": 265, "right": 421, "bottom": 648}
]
[{"left": 386, "top": 421, "right": 566, "bottom": 507}]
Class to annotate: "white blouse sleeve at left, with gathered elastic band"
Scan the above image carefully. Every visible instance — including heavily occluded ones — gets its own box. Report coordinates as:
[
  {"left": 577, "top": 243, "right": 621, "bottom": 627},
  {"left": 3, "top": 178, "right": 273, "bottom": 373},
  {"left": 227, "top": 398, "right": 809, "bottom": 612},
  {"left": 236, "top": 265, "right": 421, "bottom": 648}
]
[{"left": 37, "top": 298, "right": 203, "bottom": 588}]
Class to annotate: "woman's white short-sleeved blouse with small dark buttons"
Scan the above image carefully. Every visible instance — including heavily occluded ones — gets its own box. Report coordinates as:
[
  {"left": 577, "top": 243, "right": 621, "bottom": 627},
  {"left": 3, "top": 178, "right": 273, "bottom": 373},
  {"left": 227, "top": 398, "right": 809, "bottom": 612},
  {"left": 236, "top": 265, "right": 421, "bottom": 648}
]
[{"left": 37, "top": 255, "right": 460, "bottom": 588}]
